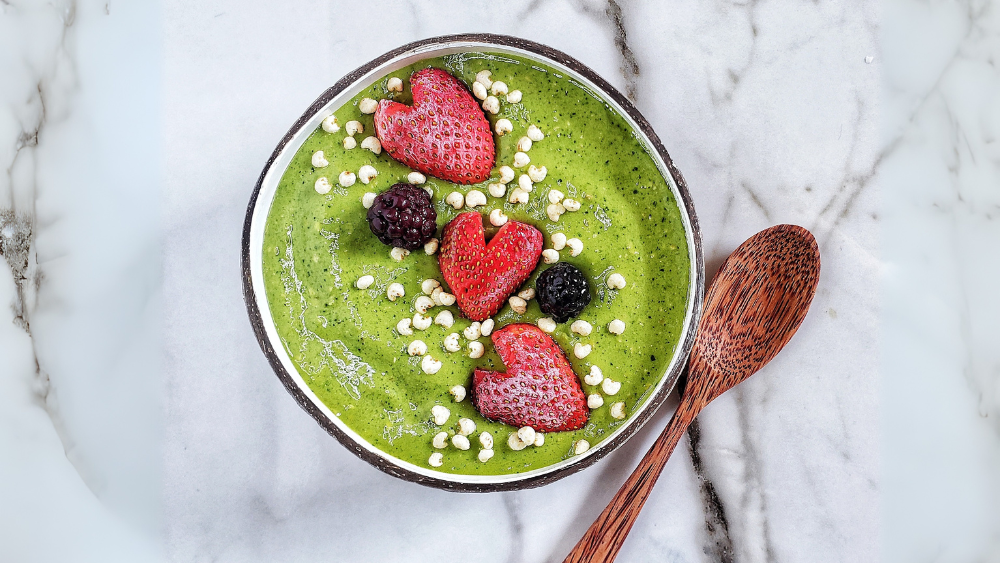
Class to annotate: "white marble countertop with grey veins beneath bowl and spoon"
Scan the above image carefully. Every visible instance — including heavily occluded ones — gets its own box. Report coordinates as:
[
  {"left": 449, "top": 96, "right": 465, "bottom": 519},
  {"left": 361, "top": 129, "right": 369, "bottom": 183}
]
[{"left": 0, "top": 0, "right": 1000, "bottom": 563}]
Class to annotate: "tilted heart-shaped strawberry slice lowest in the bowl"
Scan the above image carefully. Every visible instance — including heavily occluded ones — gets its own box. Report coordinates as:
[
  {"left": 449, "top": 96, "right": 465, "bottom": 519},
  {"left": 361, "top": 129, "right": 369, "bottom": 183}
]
[{"left": 472, "top": 324, "right": 590, "bottom": 432}]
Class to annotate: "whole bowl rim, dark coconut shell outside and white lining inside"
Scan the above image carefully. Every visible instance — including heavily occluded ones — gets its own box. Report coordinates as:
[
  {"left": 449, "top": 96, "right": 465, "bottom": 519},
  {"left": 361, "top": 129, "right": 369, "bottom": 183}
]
[{"left": 241, "top": 33, "right": 705, "bottom": 492}]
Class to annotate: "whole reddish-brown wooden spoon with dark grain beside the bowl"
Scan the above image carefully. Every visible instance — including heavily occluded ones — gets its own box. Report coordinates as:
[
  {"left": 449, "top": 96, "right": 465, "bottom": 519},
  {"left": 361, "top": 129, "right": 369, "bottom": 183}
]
[{"left": 564, "top": 225, "right": 819, "bottom": 563}]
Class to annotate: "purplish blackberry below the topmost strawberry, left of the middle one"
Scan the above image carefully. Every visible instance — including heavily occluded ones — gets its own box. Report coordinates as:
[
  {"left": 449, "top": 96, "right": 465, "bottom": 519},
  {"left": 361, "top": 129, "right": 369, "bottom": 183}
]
[{"left": 368, "top": 183, "right": 437, "bottom": 250}]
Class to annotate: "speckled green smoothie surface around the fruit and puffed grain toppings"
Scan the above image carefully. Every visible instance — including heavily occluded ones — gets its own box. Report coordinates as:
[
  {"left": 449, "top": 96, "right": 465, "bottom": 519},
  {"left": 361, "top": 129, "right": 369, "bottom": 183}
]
[{"left": 262, "top": 52, "right": 690, "bottom": 475}]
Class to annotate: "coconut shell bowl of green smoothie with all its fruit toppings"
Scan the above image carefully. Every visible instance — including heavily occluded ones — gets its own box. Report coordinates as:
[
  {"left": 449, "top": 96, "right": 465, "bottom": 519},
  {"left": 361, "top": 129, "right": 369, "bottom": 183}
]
[{"left": 242, "top": 34, "right": 705, "bottom": 492}]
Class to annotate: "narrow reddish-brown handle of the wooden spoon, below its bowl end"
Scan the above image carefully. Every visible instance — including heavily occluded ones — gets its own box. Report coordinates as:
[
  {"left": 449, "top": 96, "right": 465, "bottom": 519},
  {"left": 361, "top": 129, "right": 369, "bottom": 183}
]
[{"left": 563, "top": 389, "right": 705, "bottom": 563}]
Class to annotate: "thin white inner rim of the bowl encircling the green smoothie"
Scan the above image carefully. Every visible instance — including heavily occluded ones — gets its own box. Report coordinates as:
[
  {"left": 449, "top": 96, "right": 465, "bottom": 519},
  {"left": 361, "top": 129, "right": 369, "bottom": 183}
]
[{"left": 250, "top": 41, "right": 697, "bottom": 484}]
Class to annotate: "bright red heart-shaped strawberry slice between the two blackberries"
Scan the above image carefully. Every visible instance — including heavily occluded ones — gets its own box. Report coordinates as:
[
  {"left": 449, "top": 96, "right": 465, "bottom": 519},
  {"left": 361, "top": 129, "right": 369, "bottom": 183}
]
[{"left": 438, "top": 211, "right": 543, "bottom": 321}]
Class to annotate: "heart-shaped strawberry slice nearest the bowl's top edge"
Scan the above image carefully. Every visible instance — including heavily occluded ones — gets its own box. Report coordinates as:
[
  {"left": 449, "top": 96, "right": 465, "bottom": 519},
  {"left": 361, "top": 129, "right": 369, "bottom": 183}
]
[{"left": 375, "top": 68, "right": 496, "bottom": 184}]
